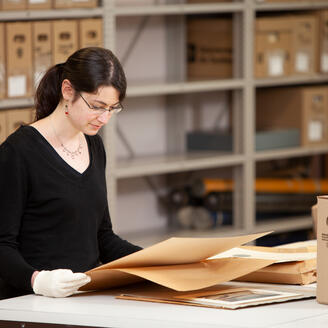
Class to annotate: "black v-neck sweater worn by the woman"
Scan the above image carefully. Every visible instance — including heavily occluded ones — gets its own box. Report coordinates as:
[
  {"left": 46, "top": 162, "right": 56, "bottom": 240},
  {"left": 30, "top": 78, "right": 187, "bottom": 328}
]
[{"left": 0, "top": 126, "right": 140, "bottom": 292}]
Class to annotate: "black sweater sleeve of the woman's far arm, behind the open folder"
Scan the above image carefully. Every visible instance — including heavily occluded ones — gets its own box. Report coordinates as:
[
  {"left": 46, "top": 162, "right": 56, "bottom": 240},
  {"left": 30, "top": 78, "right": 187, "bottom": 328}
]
[{"left": 98, "top": 206, "right": 141, "bottom": 263}]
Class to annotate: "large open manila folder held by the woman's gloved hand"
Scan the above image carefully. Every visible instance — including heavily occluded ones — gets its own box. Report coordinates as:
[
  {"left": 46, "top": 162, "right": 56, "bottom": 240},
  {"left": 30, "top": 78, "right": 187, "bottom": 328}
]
[{"left": 81, "top": 232, "right": 274, "bottom": 291}]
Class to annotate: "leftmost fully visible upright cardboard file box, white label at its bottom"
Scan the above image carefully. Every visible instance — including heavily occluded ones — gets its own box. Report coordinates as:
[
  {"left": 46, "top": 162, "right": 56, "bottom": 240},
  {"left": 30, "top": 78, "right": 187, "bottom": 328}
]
[{"left": 6, "top": 22, "right": 32, "bottom": 98}]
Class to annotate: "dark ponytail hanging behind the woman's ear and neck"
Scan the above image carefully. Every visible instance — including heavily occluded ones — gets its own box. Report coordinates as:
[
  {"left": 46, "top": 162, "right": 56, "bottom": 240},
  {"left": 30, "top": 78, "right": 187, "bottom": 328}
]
[{"left": 34, "top": 63, "right": 64, "bottom": 120}]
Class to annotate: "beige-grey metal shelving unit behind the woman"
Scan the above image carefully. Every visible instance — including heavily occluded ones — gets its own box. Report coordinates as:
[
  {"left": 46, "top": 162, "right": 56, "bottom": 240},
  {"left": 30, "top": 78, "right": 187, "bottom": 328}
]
[{"left": 0, "top": 0, "right": 322, "bottom": 245}]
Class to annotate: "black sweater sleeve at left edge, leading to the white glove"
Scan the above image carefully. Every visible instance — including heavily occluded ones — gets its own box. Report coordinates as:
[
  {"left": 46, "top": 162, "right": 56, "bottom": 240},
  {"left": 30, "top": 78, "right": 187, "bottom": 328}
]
[{"left": 0, "top": 142, "right": 35, "bottom": 291}]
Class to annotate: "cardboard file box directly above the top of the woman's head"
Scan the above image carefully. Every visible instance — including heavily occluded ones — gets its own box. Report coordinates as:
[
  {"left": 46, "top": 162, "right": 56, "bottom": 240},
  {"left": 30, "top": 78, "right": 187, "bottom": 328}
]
[{"left": 79, "top": 18, "right": 103, "bottom": 48}]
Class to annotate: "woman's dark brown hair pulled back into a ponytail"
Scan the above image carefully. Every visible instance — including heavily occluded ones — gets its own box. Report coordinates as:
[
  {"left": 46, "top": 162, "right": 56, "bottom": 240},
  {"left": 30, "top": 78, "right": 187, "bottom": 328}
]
[{"left": 34, "top": 47, "right": 126, "bottom": 120}]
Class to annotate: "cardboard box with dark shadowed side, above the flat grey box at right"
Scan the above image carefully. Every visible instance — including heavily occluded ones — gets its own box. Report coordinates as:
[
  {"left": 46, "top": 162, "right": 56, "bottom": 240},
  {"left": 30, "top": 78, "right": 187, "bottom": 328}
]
[{"left": 256, "top": 87, "right": 328, "bottom": 146}]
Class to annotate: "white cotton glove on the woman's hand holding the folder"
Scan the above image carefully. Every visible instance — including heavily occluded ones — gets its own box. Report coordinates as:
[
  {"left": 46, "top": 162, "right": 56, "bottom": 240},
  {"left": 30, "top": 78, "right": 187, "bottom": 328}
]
[{"left": 33, "top": 269, "right": 91, "bottom": 297}]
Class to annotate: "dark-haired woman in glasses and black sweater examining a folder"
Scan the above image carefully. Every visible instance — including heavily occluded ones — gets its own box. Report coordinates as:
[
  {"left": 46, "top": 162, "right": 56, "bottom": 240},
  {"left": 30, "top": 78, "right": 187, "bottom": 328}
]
[{"left": 0, "top": 47, "right": 140, "bottom": 298}]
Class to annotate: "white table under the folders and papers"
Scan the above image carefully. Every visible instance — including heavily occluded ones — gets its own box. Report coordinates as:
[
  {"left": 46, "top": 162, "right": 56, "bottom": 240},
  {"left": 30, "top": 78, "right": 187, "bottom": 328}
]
[{"left": 0, "top": 284, "right": 328, "bottom": 328}]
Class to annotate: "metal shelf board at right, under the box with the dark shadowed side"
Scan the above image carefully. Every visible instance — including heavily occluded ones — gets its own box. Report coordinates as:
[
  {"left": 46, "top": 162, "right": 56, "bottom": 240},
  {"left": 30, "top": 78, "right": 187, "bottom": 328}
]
[{"left": 255, "top": 145, "right": 328, "bottom": 161}]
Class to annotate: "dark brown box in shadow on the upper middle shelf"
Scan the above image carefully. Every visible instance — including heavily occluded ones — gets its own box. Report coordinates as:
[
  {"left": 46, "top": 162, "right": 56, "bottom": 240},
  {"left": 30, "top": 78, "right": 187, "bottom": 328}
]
[{"left": 187, "top": 18, "right": 233, "bottom": 80}]
